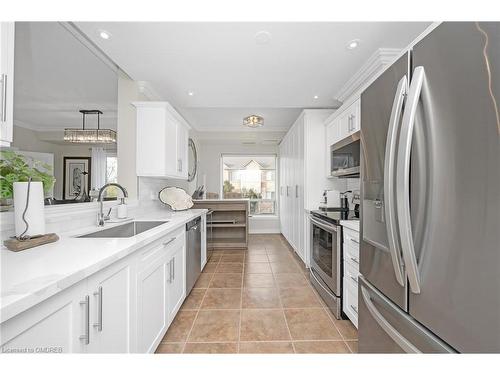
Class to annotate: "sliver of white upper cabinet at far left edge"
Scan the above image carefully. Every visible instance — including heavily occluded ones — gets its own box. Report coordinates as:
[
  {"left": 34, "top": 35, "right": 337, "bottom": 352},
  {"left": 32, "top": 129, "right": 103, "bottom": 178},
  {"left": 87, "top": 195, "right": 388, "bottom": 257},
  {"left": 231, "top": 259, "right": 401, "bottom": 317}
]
[{"left": 0, "top": 22, "right": 14, "bottom": 146}]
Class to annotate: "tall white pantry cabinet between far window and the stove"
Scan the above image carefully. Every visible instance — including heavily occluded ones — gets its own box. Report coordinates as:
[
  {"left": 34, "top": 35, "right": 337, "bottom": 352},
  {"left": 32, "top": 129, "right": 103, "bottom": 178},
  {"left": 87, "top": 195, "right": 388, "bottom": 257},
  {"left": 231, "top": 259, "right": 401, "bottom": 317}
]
[{"left": 279, "top": 109, "right": 333, "bottom": 265}]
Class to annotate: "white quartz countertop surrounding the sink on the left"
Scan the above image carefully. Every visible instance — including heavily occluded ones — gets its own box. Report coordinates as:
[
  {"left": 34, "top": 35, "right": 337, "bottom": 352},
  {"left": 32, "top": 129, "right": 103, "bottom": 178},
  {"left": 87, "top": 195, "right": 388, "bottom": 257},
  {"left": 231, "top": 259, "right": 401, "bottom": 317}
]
[{"left": 0, "top": 209, "right": 207, "bottom": 323}]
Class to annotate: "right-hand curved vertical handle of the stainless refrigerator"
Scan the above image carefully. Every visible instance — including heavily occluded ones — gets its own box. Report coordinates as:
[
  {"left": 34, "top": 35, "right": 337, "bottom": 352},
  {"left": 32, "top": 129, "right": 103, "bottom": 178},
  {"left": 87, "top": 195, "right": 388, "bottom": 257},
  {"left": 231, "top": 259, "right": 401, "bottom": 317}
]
[{"left": 396, "top": 66, "right": 425, "bottom": 294}]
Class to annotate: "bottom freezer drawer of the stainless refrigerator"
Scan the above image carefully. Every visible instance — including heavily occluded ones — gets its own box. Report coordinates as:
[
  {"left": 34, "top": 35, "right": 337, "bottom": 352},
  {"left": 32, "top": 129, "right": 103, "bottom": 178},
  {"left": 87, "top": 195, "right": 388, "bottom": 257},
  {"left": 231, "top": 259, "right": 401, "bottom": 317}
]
[{"left": 358, "top": 276, "right": 454, "bottom": 353}]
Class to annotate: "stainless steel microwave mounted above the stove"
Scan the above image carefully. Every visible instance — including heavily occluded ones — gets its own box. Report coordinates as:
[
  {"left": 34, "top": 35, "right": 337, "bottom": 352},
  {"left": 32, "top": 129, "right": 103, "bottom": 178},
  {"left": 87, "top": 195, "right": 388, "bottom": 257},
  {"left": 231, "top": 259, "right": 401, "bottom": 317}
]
[{"left": 330, "top": 132, "right": 360, "bottom": 177}]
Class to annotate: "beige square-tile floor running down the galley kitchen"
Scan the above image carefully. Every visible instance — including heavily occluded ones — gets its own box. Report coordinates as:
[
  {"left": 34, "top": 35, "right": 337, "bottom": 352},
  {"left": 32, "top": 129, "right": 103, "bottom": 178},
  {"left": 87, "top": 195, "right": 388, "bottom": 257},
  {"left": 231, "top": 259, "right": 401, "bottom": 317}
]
[{"left": 156, "top": 235, "right": 358, "bottom": 353}]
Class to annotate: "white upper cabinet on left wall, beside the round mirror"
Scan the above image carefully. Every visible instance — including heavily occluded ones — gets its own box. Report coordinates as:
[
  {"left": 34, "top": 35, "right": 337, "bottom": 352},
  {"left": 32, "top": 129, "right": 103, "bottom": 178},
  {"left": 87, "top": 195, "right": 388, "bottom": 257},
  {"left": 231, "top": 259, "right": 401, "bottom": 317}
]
[{"left": 132, "top": 102, "right": 190, "bottom": 179}]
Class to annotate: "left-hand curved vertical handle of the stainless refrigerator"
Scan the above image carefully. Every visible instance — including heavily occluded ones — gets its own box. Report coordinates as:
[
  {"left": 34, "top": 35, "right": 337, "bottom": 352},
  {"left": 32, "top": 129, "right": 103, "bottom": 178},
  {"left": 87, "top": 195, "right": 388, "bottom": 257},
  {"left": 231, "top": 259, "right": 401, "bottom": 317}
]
[{"left": 384, "top": 75, "right": 408, "bottom": 287}]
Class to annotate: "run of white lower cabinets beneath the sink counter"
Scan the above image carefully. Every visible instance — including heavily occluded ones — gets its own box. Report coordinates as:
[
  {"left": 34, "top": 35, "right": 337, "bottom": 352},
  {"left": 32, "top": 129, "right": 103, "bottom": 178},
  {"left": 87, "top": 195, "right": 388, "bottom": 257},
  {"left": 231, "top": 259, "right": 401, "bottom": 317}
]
[{"left": 0, "top": 219, "right": 201, "bottom": 353}]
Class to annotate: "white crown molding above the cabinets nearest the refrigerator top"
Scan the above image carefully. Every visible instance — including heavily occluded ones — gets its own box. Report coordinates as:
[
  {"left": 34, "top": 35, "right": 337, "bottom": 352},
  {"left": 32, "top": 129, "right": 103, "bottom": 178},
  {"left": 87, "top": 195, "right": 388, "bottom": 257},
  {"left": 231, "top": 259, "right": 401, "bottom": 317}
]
[{"left": 334, "top": 48, "right": 401, "bottom": 103}]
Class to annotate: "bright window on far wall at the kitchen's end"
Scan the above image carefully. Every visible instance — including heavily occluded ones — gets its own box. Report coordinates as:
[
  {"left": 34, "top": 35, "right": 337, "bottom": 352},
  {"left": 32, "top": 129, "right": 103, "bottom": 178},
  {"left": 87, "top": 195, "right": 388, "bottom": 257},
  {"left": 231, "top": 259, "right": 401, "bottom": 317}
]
[{"left": 221, "top": 155, "right": 276, "bottom": 215}]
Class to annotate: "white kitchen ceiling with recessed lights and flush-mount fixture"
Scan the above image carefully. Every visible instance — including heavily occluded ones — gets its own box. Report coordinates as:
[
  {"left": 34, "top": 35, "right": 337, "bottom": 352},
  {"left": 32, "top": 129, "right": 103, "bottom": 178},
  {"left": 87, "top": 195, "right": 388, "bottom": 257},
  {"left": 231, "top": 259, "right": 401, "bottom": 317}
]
[{"left": 76, "top": 22, "right": 429, "bottom": 131}]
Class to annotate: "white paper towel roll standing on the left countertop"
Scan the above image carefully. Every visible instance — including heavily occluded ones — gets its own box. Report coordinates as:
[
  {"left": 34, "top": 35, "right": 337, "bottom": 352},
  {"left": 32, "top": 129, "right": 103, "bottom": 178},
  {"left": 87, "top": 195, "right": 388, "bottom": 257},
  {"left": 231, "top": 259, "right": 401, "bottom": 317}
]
[{"left": 14, "top": 181, "right": 45, "bottom": 236}]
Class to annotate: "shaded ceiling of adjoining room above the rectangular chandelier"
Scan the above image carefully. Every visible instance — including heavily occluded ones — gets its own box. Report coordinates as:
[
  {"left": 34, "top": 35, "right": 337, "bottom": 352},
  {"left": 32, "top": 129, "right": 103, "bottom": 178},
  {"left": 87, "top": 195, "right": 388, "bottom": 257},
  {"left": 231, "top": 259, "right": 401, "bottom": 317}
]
[{"left": 14, "top": 22, "right": 118, "bottom": 131}]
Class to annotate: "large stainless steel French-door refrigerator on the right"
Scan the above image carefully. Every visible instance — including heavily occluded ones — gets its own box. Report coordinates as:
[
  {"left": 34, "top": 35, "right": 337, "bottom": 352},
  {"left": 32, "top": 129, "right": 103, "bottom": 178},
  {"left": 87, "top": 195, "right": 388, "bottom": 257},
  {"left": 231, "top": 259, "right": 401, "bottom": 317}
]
[{"left": 358, "top": 22, "right": 500, "bottom": 353}]
